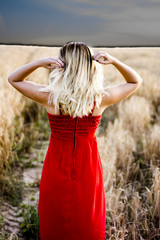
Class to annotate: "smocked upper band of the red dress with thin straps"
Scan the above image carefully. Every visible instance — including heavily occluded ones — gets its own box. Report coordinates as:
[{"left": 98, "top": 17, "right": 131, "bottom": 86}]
[{"left": 47, "top": 101, "right": 101, "bottom": 136}]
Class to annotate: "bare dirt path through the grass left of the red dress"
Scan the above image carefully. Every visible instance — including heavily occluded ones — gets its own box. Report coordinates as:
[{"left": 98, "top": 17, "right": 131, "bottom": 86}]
[{"left": 0, "top": 141, "right": 48, "bottom": 240}]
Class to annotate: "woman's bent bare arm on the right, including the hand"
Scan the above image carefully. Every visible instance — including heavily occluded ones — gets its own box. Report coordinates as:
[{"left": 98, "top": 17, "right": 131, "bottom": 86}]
[{"left": 94, "top": 51, "right": 142, "bottom": 107}]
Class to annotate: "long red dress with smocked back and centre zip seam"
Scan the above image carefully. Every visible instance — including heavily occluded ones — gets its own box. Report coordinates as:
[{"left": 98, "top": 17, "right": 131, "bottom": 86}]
[{"left": 38, "top": 102, "right": 106, "bottom": 240}]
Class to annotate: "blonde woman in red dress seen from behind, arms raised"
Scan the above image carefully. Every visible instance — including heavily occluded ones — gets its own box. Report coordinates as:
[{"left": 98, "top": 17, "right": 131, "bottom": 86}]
[{"left": 8, "top": 42, "right": 142, "bottom": 240}]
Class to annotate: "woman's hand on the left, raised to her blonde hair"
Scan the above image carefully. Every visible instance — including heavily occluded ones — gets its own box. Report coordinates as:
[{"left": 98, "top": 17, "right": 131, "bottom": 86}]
[{"left": 38, "top": 57, "right": 64, "bottom": 69}]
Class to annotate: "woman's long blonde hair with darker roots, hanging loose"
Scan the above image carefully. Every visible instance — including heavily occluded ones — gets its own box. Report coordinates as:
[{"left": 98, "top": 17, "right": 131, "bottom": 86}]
[{"left": 40, "top": 42, "right": 109, "bottom": 117}]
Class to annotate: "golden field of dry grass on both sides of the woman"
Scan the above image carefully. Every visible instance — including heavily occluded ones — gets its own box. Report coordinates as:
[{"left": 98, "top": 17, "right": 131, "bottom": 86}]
[{"left": 0, "top": 45, "right": 160, "bottom": 240}]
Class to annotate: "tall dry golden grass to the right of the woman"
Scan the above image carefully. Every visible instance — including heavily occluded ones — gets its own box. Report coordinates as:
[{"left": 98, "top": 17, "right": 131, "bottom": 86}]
[{"left": 98, "top": 48, "right": 160, "bottom": 240}]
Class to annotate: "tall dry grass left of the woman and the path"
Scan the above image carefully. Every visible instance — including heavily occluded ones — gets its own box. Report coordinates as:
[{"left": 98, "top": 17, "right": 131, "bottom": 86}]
[{"left": 0, "top": 46, "right": 55, "bottom": 204}]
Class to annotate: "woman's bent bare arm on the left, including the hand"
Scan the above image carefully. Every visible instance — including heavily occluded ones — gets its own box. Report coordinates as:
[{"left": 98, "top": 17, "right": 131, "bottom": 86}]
[{"left": 8, "top": 57, "right": 63, "bottom": 104}]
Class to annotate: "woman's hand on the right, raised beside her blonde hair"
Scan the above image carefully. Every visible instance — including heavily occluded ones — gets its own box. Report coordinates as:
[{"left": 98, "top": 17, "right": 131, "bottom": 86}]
[{"left": 94, "top": 51, "right": 115, "bottom": 64}]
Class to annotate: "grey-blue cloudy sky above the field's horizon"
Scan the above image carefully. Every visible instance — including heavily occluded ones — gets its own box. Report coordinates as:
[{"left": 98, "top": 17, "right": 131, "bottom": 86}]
[{"left": 0, "top": 0, "right": 160, "bottom": 47}]
